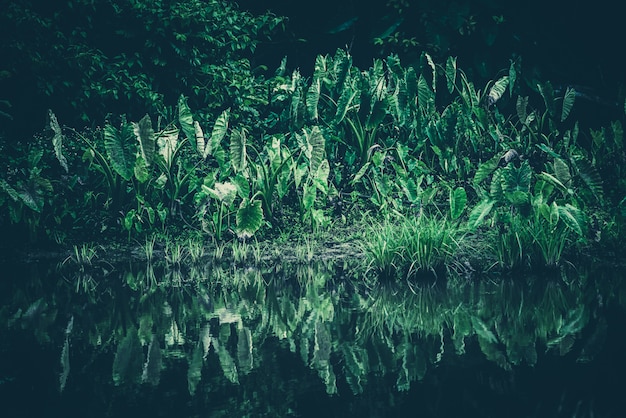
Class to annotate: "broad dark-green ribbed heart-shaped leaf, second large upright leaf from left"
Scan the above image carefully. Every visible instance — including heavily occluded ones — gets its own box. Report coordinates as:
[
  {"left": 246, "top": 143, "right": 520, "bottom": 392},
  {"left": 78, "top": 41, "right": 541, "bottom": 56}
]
[{"left": 104, "top": 121, "right": 137, "bottom": 181}]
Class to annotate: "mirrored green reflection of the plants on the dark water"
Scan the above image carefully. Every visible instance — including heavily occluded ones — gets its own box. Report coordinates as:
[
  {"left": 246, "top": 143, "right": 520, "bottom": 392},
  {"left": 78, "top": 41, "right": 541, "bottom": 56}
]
[{"left": 0, "top": 262, "right": 626, "bottom": 415}]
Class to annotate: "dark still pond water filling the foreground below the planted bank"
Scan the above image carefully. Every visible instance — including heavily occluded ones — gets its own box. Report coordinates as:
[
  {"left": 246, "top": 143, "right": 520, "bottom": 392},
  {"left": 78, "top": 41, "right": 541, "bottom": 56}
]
[{"left": 0, "top": 256, "right": 626, "bottom": 417}]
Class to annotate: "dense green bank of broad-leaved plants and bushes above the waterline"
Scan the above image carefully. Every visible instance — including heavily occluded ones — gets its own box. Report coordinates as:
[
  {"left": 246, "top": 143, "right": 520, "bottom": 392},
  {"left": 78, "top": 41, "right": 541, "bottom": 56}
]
[{"left": 0, "top": 0, "right": 626, "bottom": 274}]
